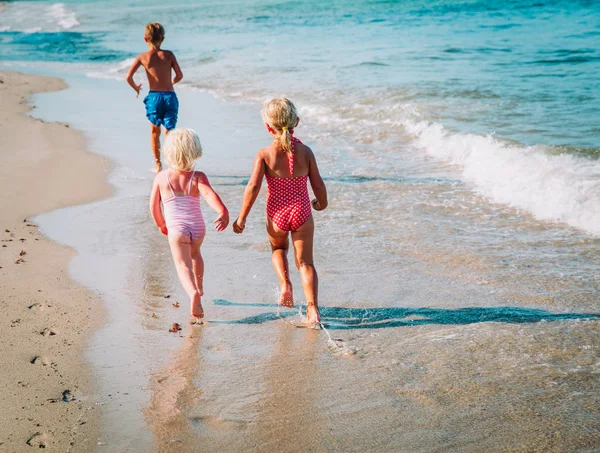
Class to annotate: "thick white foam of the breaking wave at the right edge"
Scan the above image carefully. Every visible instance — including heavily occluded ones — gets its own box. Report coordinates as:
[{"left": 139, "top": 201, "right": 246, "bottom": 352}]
[{"left": 403, "top": 121, "right": 600, "bottom": 235}]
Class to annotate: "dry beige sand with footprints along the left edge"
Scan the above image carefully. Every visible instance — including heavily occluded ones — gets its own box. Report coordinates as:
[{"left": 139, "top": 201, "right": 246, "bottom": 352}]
[{"left": 0, "top": 72, "right": 111, "bottom": 451}]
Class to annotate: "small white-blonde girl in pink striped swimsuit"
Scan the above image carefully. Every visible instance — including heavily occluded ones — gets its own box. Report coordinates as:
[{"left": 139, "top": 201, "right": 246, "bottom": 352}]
[{"left": 150, "top": 129, "right": 229, "bottom": 322}]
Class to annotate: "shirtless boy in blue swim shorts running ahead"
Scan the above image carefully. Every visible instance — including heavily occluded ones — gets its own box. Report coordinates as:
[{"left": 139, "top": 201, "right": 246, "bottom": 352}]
[{"left": 125, "top": 22, "right": 183, "bottom": 172}]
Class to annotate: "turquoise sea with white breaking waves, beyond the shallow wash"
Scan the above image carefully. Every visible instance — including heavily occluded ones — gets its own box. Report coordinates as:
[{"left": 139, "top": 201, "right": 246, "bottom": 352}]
[{"left": 0, "top": 0, "right": 600, "bottom": 234}]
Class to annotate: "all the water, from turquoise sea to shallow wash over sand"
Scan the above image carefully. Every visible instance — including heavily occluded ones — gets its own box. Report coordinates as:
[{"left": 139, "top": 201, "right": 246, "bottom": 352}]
[{"left": 0, "top": 1, "right": 600, "bottom": 452}]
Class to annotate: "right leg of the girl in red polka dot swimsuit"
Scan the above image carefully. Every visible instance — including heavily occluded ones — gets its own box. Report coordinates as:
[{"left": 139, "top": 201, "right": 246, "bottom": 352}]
[{"left": 292, "top": 215, "right": 321, "bottom": 324}]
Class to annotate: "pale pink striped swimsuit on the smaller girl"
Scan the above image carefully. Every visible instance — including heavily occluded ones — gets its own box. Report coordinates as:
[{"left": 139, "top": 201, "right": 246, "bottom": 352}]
[{"left": 163, "top": 171, "right": 206, "bottom": 242}]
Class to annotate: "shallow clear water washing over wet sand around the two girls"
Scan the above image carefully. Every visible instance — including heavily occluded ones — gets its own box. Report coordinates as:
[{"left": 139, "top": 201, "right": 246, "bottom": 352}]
[{"left": 21, "top": 73, "right": 600, "bottom": 452}]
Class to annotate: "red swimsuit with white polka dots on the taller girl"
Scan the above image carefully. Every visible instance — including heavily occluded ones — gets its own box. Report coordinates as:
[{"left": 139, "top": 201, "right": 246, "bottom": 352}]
[{"left": 266, "top": 137, "right": 311, "bottom": 231}]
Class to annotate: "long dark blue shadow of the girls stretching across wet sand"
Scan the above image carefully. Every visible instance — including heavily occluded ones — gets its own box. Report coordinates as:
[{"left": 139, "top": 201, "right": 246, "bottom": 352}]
[{"left": 213, "top": 299, "right": 600, "bottom": 330}]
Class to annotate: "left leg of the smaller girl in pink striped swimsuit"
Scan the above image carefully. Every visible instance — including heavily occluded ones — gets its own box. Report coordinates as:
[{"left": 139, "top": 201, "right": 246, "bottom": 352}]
[{"left": 169, "top": 232, "right": 204, "bottom": 318}]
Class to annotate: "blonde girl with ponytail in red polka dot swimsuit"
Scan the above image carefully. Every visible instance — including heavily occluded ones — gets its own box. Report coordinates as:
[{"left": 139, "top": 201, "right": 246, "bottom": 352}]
[{"left": 233, "top": 98, "right": 327, "bottom": 326}]
